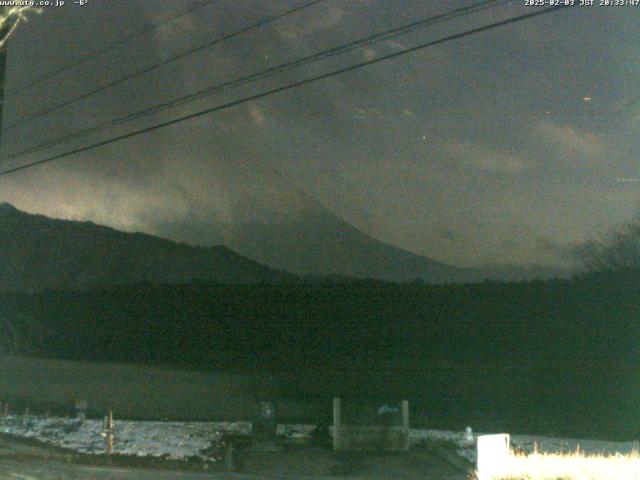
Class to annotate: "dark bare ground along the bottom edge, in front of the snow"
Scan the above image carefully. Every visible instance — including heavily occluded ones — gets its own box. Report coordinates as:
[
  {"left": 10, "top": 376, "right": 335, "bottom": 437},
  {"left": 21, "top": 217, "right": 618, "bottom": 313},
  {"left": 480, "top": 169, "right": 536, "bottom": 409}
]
[{"left": 0, "top": 436, "right": 466, "bottom": 480}]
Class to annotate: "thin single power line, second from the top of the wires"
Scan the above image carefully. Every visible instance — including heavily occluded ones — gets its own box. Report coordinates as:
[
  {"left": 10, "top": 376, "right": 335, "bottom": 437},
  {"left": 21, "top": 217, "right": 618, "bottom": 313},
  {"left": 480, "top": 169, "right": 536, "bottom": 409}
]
[{"left": 3, "top": 0, "right": 324, "bottom": 132}]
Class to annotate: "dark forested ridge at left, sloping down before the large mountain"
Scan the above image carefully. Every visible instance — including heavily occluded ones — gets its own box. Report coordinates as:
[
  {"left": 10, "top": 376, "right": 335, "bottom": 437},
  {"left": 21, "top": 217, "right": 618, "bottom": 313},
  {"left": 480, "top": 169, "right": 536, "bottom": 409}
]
[{"left": 0, "top": 203, "right": 296, "bottom": 291}]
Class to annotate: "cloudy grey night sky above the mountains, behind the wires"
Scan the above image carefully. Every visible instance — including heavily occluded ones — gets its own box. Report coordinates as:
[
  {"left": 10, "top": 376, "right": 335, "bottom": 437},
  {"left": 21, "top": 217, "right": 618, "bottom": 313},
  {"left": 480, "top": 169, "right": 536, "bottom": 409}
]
[{"left": 0, "top": 0, "right": 640, "bottom": 266}]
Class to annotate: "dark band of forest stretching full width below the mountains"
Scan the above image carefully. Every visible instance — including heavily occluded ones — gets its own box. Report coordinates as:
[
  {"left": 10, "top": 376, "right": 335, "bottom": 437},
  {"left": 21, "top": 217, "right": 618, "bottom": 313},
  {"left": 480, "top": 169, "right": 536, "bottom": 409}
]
[{"left": 5, "top": 272, "right": 640, "bottom": 369}]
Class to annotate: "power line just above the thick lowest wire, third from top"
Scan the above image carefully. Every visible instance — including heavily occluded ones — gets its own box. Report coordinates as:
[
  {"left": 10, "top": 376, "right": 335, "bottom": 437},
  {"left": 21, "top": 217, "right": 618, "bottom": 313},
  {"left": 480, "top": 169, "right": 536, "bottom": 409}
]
[{"left": 0, "top": 0, "right": 509, "bottom": 161}]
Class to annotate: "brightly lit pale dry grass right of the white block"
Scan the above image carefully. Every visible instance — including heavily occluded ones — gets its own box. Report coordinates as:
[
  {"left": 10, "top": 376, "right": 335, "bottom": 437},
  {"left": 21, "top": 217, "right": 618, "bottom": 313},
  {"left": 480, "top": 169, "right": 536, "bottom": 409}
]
[{"left": 484, "top": 451, "right": 640, "bottom": 480}]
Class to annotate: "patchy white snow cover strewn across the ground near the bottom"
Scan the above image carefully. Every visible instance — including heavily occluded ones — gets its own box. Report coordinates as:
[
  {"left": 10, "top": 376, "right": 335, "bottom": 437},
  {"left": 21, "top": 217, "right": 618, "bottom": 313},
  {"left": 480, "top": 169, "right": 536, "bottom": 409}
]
[{"left": 0, "top": 415, "right": 639, "bottom": 464}]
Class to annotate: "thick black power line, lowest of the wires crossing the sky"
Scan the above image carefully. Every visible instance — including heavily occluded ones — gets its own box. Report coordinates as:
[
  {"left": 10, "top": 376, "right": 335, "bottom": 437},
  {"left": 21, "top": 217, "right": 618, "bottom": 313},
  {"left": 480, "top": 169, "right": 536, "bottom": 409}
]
[{"left": 0, "top": 5, "right": 570, "bottom": 177}]
